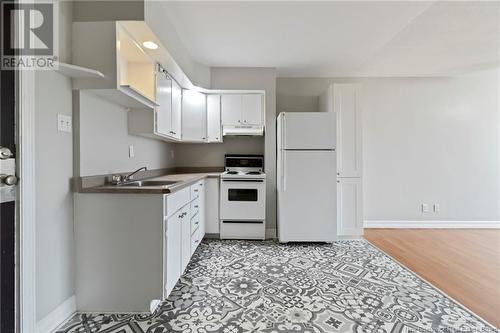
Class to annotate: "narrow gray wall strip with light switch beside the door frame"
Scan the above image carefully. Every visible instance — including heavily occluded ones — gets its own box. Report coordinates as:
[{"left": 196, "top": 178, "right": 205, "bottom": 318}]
[{"left": 34, "top": 1, "right": 75, "bottom": 320}]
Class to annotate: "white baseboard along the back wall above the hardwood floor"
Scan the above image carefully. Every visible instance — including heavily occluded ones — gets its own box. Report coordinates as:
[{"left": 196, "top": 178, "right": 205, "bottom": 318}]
[{"left": 364, "top": 220, "right": 500, "bottom": 229}]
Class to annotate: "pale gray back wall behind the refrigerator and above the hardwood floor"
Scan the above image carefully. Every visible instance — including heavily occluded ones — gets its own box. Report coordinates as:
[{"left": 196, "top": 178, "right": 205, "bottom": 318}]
[{"left": 276, "top": 69, "right": 500, "bottom": 221}]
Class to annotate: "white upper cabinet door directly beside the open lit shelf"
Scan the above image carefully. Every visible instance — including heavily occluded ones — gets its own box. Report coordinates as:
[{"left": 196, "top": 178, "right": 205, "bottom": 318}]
[{"left": 156, "top": 72, "right": 172, "bottom": 136}]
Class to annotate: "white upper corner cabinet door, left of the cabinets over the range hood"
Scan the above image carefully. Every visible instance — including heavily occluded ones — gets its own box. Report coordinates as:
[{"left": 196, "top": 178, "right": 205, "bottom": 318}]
[{"left": 182, "top": 89, "right": 207, "bottom": 142}]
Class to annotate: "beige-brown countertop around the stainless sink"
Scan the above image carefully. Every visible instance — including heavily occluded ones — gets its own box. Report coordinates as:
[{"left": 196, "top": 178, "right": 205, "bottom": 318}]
[{"left": 80, "top": 172, "right": 220, "bottom": 194}]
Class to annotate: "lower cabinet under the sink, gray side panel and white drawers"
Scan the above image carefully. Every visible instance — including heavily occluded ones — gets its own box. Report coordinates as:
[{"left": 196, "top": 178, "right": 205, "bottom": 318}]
[{"left": 74, "top": 176, "right": 209, "bottom": 312}]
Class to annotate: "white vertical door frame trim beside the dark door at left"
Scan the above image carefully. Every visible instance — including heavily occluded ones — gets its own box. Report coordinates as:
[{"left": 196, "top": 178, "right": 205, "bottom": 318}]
[{"left": 16, "top": 70, "right": 36, "bottom": 333}]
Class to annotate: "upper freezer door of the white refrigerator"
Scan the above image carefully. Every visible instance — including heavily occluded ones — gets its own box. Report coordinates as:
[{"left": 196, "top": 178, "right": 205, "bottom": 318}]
[{"left": 278, "top": 112, "right": 336, "bottom": 149}]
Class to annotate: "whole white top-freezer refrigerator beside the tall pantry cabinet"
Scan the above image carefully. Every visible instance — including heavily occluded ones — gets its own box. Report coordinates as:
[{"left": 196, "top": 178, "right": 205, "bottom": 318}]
[{"left": 277, "top": 112, "right": 337, "bottom": 243}]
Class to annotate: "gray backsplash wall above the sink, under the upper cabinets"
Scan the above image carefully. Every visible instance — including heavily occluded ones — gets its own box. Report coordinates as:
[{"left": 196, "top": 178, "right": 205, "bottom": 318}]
[{"left": 74, "top": 91, "right": 174, "bottom": 176}]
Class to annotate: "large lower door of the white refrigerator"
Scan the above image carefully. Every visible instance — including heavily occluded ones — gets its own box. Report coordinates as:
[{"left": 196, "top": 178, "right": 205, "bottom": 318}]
[{"left": 278, "top": 150, "right": 337, "bottom": 242}]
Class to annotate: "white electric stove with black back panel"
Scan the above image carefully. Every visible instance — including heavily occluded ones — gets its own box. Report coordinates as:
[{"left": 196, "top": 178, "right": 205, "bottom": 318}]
[{"left": 220, "top": 155, "right": 266, "bottom": 239}]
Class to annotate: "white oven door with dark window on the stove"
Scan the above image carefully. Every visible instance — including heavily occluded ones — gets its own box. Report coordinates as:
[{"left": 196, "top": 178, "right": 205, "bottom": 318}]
[{"left": 220, "top": 179, "right": 266, "bottom": 221}]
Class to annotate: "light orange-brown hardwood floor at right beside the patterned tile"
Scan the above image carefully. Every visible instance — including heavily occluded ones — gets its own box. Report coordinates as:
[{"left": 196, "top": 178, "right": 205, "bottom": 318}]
[{"left": 364, "top": 229, "right": 500, "bottom": 327}]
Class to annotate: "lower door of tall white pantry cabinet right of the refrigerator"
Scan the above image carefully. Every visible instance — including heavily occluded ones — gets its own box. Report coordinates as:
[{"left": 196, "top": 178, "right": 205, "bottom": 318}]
[{"left": 337, "top": 178, "right": 363, "bottom": 236}]
